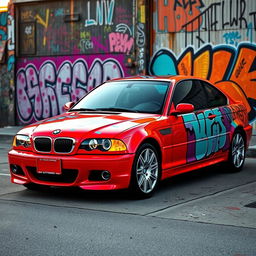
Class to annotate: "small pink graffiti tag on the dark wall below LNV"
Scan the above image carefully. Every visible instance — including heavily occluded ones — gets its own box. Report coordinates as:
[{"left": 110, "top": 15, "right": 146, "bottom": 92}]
[{"left": 109, "top": 32, "right": 134, "bottom": 54}]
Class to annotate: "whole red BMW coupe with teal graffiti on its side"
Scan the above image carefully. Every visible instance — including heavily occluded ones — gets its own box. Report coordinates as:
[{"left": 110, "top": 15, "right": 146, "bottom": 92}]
[{"left": 9, "top": 76, "right": 252, "bottom": 197}]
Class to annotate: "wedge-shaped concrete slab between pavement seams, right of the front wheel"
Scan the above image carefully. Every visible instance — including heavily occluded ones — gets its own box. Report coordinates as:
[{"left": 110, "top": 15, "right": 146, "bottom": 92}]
[{"left": 149, "top": 182, "right": 256, "bottom": 228}]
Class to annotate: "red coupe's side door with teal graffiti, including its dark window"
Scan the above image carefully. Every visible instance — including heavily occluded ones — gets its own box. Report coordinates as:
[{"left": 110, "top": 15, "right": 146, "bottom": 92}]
[{"left": 170, "top": 79, "right": 210, "bottom": 167}]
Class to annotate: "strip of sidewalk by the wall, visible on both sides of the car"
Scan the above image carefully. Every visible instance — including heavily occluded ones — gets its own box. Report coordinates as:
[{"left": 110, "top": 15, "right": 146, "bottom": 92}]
[{"left": 0, "top": 126, "right": 256, "bottom": 157}]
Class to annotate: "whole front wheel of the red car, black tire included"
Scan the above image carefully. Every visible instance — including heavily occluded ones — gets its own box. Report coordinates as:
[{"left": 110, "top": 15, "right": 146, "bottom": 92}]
[{"left": 130, "top": 143, "right": 161, "bottom": 199}]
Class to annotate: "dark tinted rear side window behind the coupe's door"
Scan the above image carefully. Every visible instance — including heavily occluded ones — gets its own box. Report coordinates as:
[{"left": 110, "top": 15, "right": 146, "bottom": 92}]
[{"left": 201, "top": 81, "right": 227, "bottom": 108}]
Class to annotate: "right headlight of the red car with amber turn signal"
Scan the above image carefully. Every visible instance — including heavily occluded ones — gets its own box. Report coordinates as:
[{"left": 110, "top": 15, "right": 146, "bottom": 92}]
[{"left": 80, "top": 139, "right": 127, "bottom": 152}]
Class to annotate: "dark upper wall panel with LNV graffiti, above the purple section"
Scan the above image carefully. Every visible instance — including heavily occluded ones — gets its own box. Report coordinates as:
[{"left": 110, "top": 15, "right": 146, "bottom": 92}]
[{"left": 19, "top": 0, "right": 134, "bottom": 56}]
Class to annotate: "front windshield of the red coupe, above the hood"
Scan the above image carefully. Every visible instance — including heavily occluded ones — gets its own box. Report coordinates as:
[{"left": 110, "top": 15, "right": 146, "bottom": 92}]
[{"left": 70, "top": 81, "right": 170, "bottom": 114}]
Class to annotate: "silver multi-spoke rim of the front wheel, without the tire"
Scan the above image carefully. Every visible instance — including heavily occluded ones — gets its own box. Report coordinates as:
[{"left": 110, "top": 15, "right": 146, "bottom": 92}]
[{"left": 136, "top": 148, "right": 159, "bottom": 194}]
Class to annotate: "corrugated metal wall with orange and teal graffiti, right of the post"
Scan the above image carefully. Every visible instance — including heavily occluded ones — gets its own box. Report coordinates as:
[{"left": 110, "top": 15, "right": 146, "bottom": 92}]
[{"left": 149, "top": 0, "right": 256, "bottom": 123}]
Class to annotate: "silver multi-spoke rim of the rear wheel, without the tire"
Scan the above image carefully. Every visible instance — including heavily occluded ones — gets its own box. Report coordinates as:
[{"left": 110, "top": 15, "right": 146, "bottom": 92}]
[{"left": 232, "top": 133, "right": 245, "bottom": 168}]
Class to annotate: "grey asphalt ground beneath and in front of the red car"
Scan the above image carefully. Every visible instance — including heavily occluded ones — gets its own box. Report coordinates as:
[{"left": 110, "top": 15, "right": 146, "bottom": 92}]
[{"left": 0, "top": 138, "right": 256, "bottom": 256}]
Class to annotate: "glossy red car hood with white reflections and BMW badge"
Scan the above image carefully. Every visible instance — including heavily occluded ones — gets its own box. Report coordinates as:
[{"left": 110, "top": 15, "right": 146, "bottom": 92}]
[{"left": 19, "top": 112, "right": 159, "bottom": 138}]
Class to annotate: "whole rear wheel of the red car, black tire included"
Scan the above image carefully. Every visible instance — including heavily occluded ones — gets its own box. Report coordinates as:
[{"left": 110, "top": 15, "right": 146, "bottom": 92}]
[{"left": 227, "top": 131, "right": 245, "bottom": 172}]
